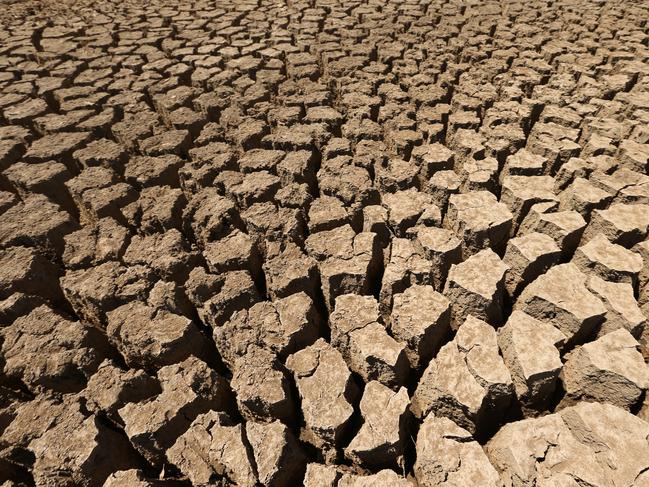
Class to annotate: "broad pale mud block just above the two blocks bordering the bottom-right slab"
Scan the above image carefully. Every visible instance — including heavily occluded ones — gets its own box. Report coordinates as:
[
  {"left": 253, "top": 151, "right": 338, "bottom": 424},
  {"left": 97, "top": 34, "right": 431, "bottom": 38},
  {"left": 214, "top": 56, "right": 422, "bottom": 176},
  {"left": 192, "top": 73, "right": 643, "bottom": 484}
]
[{"left": 514, "top": 264, "right": 606, "bottom": 344}]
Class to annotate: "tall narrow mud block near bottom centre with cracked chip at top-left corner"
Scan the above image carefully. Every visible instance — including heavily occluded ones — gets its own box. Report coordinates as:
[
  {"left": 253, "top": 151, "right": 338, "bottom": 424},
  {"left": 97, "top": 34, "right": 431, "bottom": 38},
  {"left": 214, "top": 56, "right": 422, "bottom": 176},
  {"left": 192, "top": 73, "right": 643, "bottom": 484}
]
[{"left": 286, "top": 339, "right": 358, "bottom": 459}]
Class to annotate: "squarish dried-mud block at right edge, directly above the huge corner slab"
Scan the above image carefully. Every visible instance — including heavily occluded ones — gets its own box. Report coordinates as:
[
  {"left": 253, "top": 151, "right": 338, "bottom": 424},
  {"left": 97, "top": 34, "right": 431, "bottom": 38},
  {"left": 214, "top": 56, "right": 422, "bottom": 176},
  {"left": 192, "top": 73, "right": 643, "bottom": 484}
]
[{"left": 561, "top": 329, "right": 649, "bottom": 410}]
